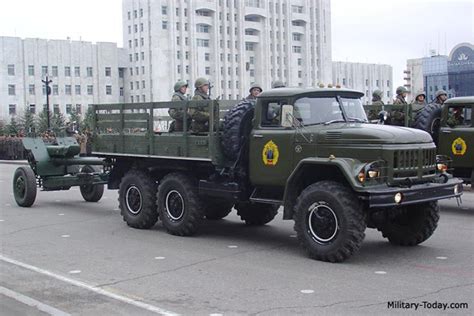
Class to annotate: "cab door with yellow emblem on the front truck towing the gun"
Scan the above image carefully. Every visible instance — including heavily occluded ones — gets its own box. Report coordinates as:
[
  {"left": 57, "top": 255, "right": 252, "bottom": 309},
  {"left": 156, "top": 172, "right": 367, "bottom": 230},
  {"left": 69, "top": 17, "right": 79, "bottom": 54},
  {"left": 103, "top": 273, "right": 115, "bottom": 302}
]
[{"left": 249, "top": 99, "right": 295, "bottom": 186}]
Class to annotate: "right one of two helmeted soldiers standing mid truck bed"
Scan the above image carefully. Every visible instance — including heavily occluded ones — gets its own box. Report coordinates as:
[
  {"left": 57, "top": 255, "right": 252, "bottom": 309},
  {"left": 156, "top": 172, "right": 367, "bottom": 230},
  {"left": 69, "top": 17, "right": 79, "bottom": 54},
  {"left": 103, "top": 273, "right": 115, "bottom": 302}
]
[{"left": 189, "top": 78, "right": 211, "bottom": 133}]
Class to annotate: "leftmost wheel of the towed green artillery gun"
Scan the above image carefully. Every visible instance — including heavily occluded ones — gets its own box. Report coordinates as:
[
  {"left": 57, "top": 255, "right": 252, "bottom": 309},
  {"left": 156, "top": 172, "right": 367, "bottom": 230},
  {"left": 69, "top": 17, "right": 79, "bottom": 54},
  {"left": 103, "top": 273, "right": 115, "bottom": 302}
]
[{"left": 13, "top": 167, "right": 37, "bottom": 207}]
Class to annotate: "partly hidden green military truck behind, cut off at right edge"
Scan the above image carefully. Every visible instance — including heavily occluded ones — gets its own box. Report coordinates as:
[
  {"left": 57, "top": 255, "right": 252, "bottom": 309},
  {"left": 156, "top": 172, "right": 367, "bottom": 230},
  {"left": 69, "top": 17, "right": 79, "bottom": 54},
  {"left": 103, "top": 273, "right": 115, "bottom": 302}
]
[{"left": 364, "top": 97, "right": 474, "bottom": 183}]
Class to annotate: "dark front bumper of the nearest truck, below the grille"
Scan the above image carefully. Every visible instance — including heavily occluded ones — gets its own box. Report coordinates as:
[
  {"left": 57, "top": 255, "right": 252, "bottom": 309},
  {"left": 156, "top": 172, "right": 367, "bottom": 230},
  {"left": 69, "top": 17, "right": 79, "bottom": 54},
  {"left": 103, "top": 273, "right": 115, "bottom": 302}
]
[{"left": 363, "top": 178, "right": 463, "bottom": 208}]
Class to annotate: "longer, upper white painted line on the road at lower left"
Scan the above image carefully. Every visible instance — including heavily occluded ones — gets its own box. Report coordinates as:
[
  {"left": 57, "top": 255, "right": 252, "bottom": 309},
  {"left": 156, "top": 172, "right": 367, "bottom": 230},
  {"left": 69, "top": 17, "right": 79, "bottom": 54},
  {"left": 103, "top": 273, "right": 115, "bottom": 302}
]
[{"left": 0, "top": 254, "right": 179, "bottom": 316}]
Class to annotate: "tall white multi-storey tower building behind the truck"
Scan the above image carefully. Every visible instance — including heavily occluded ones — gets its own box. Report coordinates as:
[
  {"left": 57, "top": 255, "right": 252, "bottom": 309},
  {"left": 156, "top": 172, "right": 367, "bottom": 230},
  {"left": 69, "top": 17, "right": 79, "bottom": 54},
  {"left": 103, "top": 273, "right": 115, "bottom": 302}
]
[{"left": 122, "top": 0, "right": 331, "bottom": 102}]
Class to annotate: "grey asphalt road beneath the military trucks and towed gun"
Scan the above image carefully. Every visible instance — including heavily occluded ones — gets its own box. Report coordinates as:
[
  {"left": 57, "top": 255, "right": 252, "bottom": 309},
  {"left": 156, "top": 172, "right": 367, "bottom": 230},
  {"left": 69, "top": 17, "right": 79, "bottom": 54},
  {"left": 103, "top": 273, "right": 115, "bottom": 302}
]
[{"left": 0, "top": 165, "right": 474, "bottom": 315}]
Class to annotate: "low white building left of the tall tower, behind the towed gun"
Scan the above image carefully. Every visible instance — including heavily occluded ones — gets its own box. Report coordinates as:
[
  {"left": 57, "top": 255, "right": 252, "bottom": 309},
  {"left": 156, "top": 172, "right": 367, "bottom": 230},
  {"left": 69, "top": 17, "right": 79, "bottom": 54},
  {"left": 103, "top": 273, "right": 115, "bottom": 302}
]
[{"left": 0, "top": 37, "right": 128, "bottom": 120}]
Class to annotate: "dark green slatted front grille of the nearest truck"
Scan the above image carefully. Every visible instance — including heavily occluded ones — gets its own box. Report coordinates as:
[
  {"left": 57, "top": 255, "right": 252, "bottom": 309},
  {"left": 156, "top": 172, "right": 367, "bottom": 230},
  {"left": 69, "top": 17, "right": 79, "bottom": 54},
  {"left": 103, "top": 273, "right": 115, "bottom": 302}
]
[{"left": 393, "top": 148, "right": 436, "bottom": 178}]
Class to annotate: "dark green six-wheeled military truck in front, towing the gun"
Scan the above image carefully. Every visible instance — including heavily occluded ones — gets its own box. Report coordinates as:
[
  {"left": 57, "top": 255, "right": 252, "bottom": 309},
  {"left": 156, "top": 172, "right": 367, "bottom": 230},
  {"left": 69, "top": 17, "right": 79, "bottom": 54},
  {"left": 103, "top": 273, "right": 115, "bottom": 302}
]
[{"left": 13, "top": 88, "right": 462, "bottom": 262}]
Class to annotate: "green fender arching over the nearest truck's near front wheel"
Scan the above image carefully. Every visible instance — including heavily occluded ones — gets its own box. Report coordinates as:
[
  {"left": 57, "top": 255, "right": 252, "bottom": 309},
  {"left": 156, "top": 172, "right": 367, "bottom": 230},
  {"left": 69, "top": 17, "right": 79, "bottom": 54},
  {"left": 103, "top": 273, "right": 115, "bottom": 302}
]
[{"left": 283, "top": 158, "right": 364, "bottom": 219}]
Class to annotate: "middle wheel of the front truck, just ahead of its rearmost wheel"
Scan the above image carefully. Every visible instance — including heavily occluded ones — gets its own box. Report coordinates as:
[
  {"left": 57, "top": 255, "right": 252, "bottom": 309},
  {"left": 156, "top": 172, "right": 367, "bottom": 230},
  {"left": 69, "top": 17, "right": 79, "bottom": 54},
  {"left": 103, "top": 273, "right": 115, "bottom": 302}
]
[{"left": 157, "top": 172, "right": 204, "bottom": 236}]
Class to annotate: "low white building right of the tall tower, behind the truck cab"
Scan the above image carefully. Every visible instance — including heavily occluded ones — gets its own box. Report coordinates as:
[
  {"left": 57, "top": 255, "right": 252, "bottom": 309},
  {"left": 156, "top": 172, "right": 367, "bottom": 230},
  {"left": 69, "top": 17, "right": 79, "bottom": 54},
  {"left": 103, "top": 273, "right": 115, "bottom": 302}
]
[{"left": 332, "top": 61, "right": 393, "bottom": 104}]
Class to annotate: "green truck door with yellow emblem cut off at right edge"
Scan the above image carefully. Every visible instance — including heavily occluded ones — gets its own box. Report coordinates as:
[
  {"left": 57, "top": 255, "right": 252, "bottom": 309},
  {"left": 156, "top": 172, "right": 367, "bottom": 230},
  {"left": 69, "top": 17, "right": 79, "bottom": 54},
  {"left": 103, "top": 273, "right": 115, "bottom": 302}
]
[{"left": 438, "top": 104, "right": 474, "bottom": 178}]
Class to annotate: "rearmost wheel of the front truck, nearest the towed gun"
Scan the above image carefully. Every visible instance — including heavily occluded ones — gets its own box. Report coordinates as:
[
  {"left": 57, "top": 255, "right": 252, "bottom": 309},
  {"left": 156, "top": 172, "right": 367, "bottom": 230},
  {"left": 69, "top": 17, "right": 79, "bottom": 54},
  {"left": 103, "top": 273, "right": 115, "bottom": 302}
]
[{"left": 119, "top": 169, "right": 158, "bottom": 229}]
